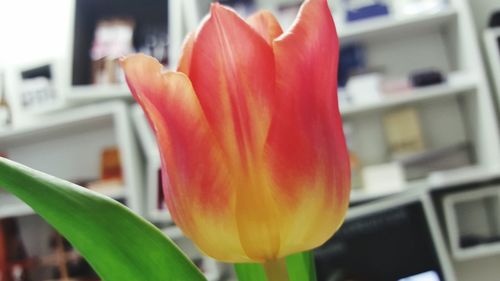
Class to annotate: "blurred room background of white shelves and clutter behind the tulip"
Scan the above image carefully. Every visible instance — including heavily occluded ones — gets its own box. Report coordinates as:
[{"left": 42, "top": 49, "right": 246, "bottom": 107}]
[{"left": 0, "top": 0, "right": 500, "bottom": 281}]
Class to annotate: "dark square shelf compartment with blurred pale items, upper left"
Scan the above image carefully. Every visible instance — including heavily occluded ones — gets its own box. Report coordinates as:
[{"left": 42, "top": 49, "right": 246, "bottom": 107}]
[{"left": 71, "top": 0, "right": 169, "bottom": 85}]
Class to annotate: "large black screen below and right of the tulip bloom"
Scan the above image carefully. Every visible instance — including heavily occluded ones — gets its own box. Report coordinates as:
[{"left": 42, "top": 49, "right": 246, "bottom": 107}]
[{"left": 315, "top": 202, "right": 444, "bottom": 281}]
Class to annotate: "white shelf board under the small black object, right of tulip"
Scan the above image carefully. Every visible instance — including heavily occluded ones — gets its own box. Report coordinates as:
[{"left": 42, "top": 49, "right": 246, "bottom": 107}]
[{"left": 340, "top": 74, "right": 477, "bottom": 116}]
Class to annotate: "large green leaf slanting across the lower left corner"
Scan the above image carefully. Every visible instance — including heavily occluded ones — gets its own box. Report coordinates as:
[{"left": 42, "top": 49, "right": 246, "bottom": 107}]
[{"left": 0, "top": 157, "right": 206, "bottom": 281}]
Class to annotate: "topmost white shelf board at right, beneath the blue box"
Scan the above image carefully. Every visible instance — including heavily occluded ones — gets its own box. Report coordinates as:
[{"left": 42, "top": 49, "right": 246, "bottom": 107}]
[{"left": 338, "top": 8, "right": 457, "bottom": 44}]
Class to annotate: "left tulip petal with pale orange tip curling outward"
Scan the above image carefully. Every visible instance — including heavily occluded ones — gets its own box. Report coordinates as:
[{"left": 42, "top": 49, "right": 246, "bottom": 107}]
[{"left": 117, "top": 55, "right": 248, "bottom": 262}]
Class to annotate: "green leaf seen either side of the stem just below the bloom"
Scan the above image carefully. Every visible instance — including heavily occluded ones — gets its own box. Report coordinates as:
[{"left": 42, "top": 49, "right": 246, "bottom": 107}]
[{"left": 234, "top": 252, "right": 316, "bottom": 281}]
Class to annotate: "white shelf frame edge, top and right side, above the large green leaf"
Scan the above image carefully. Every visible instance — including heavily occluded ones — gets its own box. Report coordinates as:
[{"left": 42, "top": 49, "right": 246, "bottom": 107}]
[{"left": 0, "top": 101, "right": 141, "bottom": 215}]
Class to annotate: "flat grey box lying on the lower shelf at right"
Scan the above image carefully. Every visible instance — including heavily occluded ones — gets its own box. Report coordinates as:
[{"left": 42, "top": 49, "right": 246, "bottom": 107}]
[{"left": 400, "top": 143, "right": 473, "bottom": 180}]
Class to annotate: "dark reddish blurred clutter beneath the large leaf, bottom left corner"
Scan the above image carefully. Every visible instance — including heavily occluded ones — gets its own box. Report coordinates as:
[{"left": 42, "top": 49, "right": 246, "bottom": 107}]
[{"left": 0, "top": 217, "right": 100, "bottom": 281}]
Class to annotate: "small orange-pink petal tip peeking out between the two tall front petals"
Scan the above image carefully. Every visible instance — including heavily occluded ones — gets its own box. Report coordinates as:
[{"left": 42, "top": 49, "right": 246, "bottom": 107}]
[{"left": 247, "top": 11, "right": 283, "bottom": 45}]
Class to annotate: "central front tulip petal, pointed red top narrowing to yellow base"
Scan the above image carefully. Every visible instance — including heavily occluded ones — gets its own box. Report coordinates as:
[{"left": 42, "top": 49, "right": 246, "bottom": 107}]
[{"left": 189, "top": 4, "right": 279, "bottom": 260}]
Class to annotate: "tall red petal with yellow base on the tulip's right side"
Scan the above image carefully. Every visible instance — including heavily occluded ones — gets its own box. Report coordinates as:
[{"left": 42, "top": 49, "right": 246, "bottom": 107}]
[{"left": 266, "top": 0, "right": 350, "bottom": 256}]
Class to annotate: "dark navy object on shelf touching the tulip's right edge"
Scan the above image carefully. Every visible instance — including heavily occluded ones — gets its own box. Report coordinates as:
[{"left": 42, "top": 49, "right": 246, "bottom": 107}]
[{"left": 338, "top": 45, "right": 366, "bottom": 88}]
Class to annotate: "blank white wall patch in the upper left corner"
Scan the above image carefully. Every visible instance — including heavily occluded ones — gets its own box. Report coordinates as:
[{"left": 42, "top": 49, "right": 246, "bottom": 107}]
[{"left": 0, "top": 0, "right": 73, "bottom": 68}]
